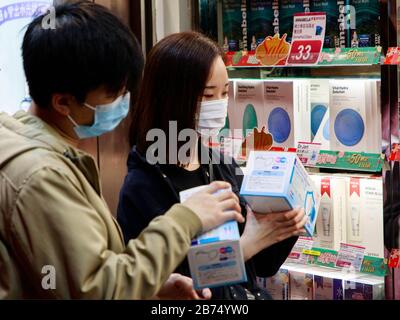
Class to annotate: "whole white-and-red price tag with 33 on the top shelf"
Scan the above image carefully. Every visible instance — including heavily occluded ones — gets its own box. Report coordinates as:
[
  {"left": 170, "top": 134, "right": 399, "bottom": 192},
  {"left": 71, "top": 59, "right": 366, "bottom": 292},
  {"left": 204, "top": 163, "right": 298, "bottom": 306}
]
[{"left": 287, "top": 12, "right": 326, "bottom": 66}]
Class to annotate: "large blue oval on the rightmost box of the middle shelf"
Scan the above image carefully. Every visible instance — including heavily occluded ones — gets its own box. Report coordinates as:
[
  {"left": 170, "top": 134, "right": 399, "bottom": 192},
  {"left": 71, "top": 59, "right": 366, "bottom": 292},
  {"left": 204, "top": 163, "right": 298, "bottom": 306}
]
[{"left": 335, "top": 109, "right": 365, "bottom": 147}]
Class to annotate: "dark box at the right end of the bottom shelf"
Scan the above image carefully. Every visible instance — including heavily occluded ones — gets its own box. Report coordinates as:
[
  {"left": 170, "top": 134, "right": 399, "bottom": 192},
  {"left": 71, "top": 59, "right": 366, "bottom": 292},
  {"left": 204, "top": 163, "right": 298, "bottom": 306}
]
[{"left": 344, "top": 276, "right": 385, "bottom": 300}]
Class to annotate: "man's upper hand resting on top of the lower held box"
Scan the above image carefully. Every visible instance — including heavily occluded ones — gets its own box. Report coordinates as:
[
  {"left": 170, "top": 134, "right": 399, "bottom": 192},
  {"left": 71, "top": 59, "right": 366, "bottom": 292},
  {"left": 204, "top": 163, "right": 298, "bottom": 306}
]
[{"left": 183, "top": 182, "right": 244, "bottom": 232}]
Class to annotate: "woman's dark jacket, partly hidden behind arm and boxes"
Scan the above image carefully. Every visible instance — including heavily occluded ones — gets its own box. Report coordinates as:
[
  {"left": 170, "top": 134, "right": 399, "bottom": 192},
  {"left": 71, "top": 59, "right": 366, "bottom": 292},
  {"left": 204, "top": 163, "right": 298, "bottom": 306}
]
[{"left": 117, "top": 147, "right": 297, "bottom": 300}]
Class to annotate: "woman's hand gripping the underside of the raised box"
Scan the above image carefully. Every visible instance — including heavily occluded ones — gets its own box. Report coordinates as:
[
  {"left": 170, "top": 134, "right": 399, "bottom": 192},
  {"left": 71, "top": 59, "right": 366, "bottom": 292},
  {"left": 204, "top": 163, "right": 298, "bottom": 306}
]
[{"left": 240, "top": 207, "right": 307, "bottom": 261}]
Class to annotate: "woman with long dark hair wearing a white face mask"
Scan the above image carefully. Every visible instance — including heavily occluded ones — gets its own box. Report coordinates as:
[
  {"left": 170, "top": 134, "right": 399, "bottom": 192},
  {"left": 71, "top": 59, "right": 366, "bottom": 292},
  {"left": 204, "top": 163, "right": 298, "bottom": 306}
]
[{"left": 118, "top": 32, "right": 306, "bottom": 299}]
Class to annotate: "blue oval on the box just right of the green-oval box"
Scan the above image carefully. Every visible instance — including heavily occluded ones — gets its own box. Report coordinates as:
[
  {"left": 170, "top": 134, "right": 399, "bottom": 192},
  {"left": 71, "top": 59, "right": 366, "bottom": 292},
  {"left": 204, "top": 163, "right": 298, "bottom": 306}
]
[{"left": 268, "top": 107, "right": 292, "bottom": 143}]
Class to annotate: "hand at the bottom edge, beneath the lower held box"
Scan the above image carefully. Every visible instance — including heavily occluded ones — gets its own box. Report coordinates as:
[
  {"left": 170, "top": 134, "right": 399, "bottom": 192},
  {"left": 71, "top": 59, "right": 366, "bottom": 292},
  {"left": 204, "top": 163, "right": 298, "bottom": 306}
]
[{"left": 156, "top": 273, "right": 211, "bottom": 300}]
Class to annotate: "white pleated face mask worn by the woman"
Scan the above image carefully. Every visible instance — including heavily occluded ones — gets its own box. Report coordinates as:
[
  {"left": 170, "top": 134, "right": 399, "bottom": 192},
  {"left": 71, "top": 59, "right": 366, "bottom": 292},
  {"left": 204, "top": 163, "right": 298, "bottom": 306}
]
[{"left": 196, "top": 99, "right": 228, "bottom": 137}]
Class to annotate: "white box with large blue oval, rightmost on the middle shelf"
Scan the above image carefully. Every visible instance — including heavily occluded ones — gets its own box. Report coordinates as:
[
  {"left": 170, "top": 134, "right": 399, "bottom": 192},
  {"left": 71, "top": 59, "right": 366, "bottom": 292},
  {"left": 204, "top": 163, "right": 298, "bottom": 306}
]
[{"left": 329, "top": 80, "right": 373, "bottom": 152}]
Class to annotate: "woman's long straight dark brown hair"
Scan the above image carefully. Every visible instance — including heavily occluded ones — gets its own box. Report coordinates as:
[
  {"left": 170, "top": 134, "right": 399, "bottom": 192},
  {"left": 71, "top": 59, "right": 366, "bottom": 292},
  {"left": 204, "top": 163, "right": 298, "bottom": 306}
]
[{"left": 130, "top": 32, "right": 224, "bottom": 160}]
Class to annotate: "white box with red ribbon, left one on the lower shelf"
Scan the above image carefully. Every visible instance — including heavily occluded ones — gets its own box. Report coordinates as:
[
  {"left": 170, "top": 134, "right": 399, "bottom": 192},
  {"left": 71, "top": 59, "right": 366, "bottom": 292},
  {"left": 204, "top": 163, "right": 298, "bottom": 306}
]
[{"left": 311, "top": 175, "right": 347, "bottom": 251}]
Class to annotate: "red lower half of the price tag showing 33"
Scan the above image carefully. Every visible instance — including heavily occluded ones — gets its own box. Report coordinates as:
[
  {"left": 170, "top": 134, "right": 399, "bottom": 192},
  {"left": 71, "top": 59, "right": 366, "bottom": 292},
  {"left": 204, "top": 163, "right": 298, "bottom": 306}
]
[{"left": 287, "top": 40, "right": 323, "bottom": 65}]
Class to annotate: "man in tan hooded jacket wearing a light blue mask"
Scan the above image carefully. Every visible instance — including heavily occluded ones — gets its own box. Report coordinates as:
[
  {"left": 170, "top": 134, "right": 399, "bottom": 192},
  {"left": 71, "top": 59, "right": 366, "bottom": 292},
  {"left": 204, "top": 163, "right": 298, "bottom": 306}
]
[{"left": 0, "top": 2, "right": 243, "bottom": 299}]
